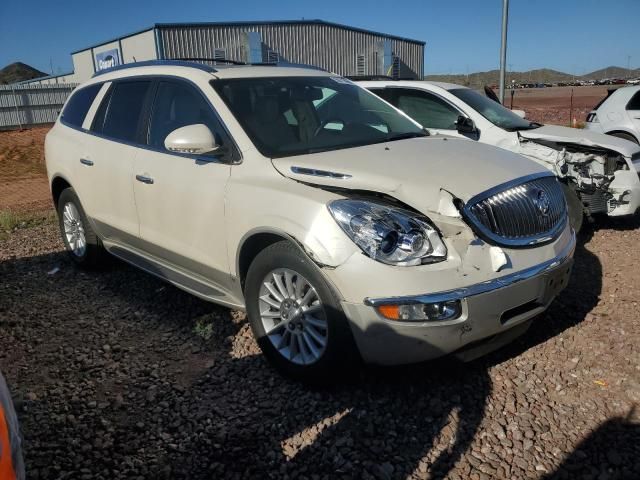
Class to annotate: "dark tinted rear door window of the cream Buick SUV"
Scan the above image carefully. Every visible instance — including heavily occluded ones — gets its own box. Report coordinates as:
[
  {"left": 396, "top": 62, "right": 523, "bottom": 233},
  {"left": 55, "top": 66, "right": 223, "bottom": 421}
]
[{"left": 100, "top": 81, "right": 151, "bottom": 142}]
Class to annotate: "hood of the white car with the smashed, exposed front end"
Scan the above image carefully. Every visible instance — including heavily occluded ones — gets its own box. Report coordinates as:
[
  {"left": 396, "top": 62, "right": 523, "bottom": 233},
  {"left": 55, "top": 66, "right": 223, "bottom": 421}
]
[{"left": 518, "top": 125, "right": 640, "bottom": 157}]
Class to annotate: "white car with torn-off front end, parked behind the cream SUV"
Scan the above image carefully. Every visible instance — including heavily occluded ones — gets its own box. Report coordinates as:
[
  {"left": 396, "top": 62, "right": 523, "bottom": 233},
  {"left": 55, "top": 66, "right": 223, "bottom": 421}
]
[{"left": 360, "top": 80, "right": 640, "bottom": 230}]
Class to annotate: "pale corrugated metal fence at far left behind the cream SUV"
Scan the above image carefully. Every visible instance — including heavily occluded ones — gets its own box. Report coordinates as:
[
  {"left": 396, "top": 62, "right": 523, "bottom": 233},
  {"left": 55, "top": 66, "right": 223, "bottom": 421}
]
[{"left": 0, "top": 83, "right": 77, "bottom": 130}]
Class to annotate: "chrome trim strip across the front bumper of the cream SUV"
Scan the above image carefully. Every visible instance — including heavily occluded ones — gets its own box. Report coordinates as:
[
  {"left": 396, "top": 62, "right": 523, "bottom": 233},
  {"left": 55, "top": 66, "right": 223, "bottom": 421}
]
[{"left": 364, "top": 230, "right": 576, "bottom": 307}]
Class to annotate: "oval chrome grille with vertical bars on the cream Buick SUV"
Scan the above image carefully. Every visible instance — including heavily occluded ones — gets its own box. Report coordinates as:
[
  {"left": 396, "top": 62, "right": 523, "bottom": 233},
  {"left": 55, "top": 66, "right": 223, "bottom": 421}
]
[{"left": 464, "top": 174, "right": 567, "bottom": 247}]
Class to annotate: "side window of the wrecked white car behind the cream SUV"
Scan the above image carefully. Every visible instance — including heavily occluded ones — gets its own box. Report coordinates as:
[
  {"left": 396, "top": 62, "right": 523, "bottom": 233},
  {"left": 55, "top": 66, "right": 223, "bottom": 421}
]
[{"left": 394, "top": 90, "right": 460, "bottom": 130}]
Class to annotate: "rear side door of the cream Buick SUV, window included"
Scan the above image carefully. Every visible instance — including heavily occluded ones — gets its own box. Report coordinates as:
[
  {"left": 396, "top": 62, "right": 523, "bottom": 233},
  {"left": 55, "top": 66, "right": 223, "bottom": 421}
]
[{"left": 81, "top": 79, "right": 152, "bottom": 245}]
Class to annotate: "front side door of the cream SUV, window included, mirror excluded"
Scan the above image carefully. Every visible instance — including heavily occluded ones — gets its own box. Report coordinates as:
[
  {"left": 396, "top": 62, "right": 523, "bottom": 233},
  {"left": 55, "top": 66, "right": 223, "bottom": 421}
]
[{"left": 132, "top": 78, "right": 239, "bottom": 285}]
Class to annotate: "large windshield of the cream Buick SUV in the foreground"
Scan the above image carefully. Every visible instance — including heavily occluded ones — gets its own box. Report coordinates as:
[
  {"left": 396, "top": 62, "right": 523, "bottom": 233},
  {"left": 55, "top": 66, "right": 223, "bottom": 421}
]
[{"left": 211, "top": 77, "right": 426, "bottom": 158}]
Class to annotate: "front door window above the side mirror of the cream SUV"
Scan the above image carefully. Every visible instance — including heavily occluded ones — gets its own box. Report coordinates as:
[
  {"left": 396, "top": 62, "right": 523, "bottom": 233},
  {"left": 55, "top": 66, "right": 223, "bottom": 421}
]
[{"left": 149, "top": 82, "right": 221, "bottom": 153}]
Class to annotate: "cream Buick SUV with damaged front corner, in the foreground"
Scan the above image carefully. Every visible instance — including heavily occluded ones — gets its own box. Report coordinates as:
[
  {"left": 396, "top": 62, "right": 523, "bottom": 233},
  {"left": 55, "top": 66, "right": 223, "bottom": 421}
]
[{"left": 45, "top": 61, "right": 575, "bottom": 380}]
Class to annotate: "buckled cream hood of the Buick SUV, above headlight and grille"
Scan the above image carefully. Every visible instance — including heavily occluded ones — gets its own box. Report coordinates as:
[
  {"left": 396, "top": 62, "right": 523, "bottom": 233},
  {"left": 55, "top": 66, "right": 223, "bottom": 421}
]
[{"left": 273, "top": 137, "right": 550, "bottom": 213}]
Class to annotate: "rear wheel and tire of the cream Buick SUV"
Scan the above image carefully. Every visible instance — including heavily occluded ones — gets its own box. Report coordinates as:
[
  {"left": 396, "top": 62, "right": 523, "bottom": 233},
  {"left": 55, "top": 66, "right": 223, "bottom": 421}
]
[{"left": 57, "top": 188, "right": 106, "bottom": 268}]
